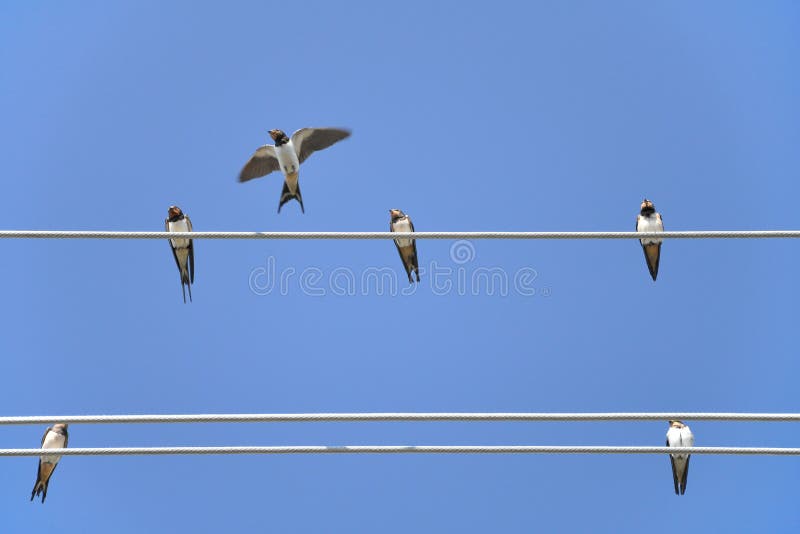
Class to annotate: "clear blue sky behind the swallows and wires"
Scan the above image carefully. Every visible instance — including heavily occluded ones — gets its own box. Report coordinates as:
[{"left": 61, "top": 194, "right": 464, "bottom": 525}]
[{"left": 0, "top": 1, "right": 800, "bottom": 533}]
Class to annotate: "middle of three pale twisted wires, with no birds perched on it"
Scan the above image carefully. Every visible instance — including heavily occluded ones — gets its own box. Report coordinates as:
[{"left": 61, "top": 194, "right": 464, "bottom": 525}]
[{"left": 0, "top": 412, "right": 800, "bottom": 425}]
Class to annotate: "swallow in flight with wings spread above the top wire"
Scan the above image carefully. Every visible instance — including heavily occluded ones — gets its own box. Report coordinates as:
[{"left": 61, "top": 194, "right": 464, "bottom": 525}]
[{"left": 239, "top": 128, "right": 350, "bottom": 213}]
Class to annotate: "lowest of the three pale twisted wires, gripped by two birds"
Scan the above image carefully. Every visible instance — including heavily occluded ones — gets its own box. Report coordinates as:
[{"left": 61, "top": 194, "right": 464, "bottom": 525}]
[{"left": 0, "top": 445, "right": 800, "bottom": 456}]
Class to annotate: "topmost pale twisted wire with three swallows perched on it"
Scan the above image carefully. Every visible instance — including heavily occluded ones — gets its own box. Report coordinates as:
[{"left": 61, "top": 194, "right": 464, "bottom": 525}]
[{"left": 0, "top": 230, "right": 800, "bottom": 239}]
